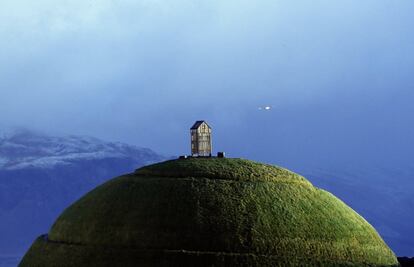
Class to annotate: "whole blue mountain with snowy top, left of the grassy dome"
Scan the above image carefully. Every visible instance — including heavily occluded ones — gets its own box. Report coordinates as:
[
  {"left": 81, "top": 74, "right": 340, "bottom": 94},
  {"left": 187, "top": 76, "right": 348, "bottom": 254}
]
[{"left": 0, "top": 131, "right": 165, "bottom": 256}]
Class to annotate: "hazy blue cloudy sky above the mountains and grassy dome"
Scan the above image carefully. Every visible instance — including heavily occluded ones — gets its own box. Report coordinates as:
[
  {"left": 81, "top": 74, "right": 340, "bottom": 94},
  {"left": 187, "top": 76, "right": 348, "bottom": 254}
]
[{"left": 0, "top": 0, "right": 414, "bottom": 170}]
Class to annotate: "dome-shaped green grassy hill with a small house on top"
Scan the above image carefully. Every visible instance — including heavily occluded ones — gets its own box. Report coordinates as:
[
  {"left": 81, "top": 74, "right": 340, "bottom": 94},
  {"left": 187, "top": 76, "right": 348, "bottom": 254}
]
[{"left": 20, "top": 158, "right": 398, "bottom": 266}]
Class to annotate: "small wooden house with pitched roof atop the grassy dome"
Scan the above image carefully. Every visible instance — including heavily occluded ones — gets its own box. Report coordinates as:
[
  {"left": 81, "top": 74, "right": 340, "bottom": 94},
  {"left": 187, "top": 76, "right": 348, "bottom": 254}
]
[{"left": 190, "top": 121, "right": 212, "bottom": 157}]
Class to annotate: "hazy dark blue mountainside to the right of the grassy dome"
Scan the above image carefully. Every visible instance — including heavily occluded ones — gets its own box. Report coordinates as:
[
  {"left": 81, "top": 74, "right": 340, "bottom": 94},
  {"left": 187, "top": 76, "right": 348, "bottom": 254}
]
[{"left": 300, "top": 165, "right": 414, "bottom": 256}]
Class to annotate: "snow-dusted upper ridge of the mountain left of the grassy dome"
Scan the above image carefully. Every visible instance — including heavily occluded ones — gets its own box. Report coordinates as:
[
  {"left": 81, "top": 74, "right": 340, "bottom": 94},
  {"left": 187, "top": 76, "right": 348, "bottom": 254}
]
[{"left": 0, "top": 130, "right": 158, "bottom": 170}]
